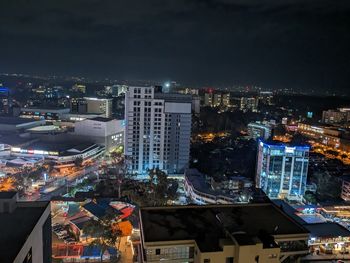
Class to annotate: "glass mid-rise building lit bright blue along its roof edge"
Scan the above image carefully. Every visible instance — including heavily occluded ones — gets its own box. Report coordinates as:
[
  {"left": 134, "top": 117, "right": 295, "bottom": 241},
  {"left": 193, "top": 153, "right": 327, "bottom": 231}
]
[{"left": 255, "top": 141, "right": 310, "bottom": 200}]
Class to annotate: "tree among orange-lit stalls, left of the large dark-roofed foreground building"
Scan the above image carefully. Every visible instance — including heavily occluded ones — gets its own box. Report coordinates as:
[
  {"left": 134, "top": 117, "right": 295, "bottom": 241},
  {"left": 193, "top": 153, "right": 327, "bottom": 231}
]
[{"left": 83, "top": 211, "right": 121, "bottom": 262}]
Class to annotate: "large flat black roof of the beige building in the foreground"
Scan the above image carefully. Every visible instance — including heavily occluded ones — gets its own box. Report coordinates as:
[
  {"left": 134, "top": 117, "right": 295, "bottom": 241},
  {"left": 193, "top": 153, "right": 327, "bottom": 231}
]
[{"left": 140, "top": 203, "right": 308, "bottom": 252}]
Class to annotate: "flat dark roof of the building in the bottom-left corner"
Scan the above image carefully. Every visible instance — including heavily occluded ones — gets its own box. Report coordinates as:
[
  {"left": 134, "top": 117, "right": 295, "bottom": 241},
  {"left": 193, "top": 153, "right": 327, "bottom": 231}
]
[{"left": 0, "top": 202, "right": 49, "bottom": 263}]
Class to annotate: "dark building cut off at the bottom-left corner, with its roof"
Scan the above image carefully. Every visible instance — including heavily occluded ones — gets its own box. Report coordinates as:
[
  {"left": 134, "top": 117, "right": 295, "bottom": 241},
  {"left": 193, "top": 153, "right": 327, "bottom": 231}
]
[{"left": 0, "top": 192, "right": 51, "bottom": 263}]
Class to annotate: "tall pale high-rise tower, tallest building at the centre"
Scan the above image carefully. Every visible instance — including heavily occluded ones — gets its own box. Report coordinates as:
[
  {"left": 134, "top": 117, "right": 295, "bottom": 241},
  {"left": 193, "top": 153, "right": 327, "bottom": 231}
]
[{"left": 124, "top": 86, "right": 191, "bottom": 176}]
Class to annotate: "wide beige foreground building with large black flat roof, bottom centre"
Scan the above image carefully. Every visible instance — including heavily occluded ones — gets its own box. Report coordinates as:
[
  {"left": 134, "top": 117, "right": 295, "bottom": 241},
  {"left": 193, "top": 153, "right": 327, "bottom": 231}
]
[{"left": 140, "top": 203, "right": 309, "bottom": 263}]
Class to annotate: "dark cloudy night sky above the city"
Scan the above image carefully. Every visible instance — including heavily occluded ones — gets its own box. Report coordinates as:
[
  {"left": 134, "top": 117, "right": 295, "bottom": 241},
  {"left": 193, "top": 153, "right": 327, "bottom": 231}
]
[{"left": 0, "top": 0, "right": 350, "bottom": 90}]
